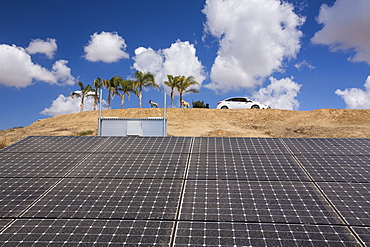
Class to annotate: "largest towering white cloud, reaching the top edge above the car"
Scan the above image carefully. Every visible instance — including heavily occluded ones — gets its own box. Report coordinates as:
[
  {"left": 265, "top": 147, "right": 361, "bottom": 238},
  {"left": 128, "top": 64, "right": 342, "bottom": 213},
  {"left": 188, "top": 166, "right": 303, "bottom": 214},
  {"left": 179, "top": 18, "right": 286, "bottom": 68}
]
[{"left": 203, "top": 0, "right": 305, "bottom": 92}]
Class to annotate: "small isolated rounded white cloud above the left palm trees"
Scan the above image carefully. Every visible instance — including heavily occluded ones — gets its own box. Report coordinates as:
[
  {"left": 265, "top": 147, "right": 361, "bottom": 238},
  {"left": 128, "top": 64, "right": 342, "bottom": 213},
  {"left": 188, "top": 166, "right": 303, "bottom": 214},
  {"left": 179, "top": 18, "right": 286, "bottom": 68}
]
[{"left": 84, "top": 31, "right": 129, "bottom": 63}]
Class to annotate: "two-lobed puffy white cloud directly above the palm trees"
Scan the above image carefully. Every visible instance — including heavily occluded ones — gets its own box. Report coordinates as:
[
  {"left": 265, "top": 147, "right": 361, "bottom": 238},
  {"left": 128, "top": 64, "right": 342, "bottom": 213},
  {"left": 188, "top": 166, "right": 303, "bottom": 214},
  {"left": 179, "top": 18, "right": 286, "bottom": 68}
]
[{"left": 133, "top": 40, "right": 206, "bottom": 88}]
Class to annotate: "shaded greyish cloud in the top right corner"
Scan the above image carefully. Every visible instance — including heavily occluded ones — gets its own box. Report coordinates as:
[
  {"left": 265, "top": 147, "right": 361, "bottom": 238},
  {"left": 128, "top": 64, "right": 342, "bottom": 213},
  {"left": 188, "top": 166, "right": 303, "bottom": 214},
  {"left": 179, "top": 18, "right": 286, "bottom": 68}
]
[{"left": 311, "top": 0, "right": 370, "bottom": 64}]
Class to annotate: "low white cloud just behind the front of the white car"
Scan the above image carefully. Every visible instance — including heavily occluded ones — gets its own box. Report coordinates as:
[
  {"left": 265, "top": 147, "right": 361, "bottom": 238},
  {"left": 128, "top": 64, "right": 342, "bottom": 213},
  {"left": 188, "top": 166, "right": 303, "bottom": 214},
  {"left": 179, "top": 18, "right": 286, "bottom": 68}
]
[{"left": 253, "top": 77, "right": 302, "bottom": 110}]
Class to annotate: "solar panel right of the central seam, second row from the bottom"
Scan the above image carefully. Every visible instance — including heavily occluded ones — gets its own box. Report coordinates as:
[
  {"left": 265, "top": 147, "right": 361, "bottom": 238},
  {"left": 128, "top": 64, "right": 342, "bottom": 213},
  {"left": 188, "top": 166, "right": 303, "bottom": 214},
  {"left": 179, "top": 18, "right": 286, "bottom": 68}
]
[{"left": 180, "top": 180, "right": 342, "bottom": 224}]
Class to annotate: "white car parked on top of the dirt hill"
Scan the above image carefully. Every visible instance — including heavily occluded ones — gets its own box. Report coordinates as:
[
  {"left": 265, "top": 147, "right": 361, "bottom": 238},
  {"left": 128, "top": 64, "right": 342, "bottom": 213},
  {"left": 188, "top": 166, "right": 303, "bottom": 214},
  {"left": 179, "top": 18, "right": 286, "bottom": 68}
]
[{"left": 217, "top": 97, "right": 271, "bottom": 109}]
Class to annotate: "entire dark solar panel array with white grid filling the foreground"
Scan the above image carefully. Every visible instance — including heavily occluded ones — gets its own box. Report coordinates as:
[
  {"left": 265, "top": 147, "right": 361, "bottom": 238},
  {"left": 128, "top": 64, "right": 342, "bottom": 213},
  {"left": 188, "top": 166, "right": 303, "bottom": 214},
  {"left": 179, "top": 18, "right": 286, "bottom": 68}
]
[{"left": 0, "top": 136, "right": 370, "bottom": 246}]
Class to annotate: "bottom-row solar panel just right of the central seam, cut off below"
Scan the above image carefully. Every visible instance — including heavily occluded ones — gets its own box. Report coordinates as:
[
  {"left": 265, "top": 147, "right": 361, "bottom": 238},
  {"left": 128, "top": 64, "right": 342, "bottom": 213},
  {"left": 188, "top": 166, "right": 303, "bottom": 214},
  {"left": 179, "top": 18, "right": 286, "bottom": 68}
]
[{"left": 175, "top": 222, "right": 361, "bottom": 246}]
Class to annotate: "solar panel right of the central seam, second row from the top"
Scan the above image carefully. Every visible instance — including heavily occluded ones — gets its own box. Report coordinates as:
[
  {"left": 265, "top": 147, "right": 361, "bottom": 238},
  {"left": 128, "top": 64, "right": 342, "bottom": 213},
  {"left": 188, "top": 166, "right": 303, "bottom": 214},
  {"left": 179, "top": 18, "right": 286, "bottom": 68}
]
[{"left": 188, "top": 153, "right": 308, "bottom": 181}]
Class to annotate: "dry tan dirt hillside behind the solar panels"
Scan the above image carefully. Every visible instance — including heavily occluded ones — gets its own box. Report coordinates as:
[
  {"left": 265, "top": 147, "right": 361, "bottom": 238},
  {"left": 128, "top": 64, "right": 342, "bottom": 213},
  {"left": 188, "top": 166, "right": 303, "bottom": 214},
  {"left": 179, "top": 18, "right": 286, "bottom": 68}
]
[{"left": 0, "top": 108, "right": 370, "bottom": 148}]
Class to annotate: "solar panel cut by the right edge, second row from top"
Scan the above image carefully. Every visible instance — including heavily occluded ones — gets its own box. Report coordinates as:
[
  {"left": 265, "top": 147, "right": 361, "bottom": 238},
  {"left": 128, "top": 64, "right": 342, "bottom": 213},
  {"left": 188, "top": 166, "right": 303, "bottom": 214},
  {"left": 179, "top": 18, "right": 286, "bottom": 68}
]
[{"left": 296, "top": 154, "right": 370, "bottom": 182}]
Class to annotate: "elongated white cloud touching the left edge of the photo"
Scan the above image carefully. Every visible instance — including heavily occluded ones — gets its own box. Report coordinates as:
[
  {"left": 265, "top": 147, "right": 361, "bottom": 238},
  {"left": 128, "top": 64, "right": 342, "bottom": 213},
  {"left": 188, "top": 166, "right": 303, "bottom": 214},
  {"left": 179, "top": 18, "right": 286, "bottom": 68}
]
[{"left": 0, "top": 44, "right": 75, "bottom": 88}]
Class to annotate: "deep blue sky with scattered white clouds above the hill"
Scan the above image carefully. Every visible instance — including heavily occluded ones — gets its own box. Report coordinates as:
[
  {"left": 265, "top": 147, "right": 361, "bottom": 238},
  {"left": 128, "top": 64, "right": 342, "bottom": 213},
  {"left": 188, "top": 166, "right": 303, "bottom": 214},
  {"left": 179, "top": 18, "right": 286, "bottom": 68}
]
[{"left": 0, "top": 0, "right": 370, "bottom": 129}]
